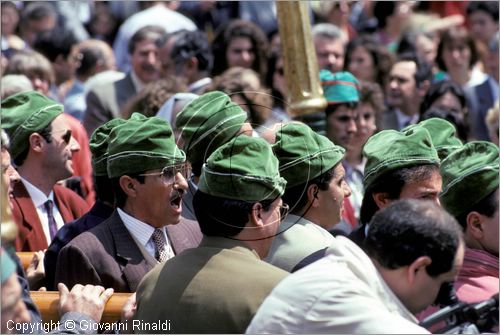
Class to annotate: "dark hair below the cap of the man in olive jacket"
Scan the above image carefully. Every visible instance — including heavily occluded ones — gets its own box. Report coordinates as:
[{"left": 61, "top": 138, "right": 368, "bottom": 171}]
[{"left": 193, "top": 190, "right": 274, "bottom": 237}]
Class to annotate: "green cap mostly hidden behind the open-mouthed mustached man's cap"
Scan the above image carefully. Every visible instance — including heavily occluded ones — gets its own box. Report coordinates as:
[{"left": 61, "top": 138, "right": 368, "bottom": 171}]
[{"left": 89, "top": 118, "right": 125, "bottom": 176}]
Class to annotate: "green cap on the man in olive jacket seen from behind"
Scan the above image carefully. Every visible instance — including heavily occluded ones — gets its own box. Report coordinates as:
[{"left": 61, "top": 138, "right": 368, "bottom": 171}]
[{"left": 198, "top": 135, "right": 286, "bottom": 202}]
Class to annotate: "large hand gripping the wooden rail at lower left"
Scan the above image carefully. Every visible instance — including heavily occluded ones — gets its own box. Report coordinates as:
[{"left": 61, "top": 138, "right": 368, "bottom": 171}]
[{"left": 57, "top": 283, "right": 113, "bottom": 322}]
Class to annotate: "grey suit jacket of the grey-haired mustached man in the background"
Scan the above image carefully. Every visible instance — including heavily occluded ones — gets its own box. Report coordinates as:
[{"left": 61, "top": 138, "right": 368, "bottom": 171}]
[{"left": 83, "top": 72, "right": 137, "bottom": 137}]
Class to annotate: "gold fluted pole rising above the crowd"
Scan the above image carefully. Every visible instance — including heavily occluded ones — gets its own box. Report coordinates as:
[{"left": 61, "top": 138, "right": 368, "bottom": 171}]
[{"left": 276, "top": 1, "right": 327, "bottom": 117}]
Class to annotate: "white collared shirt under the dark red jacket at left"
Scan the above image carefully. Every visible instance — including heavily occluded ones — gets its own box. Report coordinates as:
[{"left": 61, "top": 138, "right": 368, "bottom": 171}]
[{"left": 21, "top": 177, "right": 64, "bottom": 245}]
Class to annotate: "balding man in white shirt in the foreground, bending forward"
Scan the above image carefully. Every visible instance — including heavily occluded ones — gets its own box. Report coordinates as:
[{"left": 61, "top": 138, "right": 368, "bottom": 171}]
[{"left": 246, "top": 199, "right": 464, "bottom": 334}]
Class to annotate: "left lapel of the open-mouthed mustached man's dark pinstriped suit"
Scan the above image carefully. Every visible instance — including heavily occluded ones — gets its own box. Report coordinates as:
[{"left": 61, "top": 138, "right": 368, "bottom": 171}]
[{"left": 110, "top": 211, "right": 152, "bottom": 292}]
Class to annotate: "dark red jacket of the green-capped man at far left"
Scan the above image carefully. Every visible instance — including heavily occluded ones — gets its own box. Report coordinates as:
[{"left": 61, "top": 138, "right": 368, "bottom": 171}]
[{"left": 11, "top": 182, "right": 89, "bottom": 251}]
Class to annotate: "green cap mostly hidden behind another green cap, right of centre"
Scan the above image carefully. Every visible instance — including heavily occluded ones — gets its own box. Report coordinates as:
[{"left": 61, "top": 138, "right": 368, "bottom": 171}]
[{"left": 402, "top": 117, "right": 463, "bottom": 160}]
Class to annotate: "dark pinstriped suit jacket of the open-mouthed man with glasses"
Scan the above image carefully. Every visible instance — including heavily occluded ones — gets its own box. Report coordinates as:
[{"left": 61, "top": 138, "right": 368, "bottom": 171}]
[{"left": 54, "top": 211, "right": 201, "bottom": 292}]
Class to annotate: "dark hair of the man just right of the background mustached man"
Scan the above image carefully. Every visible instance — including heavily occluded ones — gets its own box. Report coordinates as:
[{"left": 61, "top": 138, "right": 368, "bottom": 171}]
[{"left": 170, "top": 30, "right": 213, "bottom": 72}]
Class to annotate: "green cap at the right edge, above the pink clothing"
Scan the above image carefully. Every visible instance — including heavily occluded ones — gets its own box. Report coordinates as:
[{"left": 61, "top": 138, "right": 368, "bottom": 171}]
[{"left": 439, "top": 141, "right": 499, "bottom": 217}]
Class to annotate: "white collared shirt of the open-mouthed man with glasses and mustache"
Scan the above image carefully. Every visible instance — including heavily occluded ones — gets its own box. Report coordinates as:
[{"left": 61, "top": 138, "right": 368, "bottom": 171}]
[{"left": 117, "top": 208, "right": 175, "bottom": 258}]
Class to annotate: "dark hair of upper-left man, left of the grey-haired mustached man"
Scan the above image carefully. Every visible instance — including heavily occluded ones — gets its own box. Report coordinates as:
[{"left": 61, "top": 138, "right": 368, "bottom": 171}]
[{"left": 33, "top": 27, "right": 78, "bottom": 63}]
